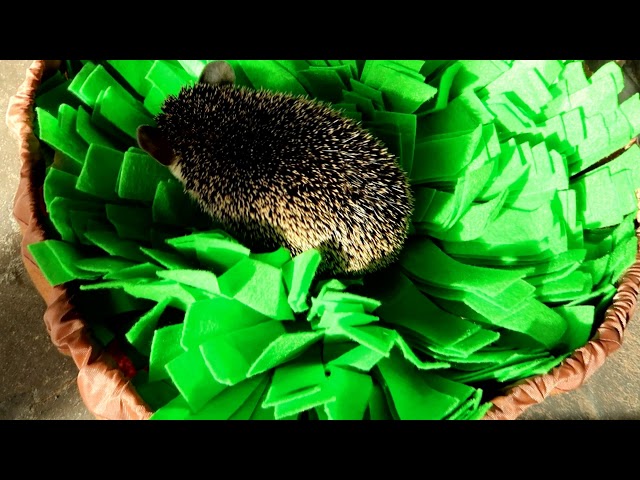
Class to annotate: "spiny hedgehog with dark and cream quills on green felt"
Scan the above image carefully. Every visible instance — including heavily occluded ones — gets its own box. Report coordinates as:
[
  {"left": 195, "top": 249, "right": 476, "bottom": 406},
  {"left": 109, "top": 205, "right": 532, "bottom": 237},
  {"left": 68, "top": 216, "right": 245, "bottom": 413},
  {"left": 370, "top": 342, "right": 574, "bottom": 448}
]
[{"left": 137, "top": 61, "right": 413, "bottom": 276}]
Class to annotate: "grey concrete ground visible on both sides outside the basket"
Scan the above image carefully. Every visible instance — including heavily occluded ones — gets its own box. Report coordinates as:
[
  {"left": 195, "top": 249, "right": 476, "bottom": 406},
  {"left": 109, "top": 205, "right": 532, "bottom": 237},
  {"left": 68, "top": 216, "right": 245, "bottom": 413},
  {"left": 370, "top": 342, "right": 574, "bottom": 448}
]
[{"left": 0, "top": 60, "right": 640, "bottom": 420}]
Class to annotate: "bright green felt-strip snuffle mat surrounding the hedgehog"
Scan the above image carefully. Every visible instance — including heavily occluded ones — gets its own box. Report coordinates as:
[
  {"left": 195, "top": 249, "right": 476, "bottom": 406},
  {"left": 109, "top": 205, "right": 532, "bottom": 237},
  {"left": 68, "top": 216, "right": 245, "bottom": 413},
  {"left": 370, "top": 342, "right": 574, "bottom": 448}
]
[{"left": 29, "top": 60, "right": 640, "bottom": 420}]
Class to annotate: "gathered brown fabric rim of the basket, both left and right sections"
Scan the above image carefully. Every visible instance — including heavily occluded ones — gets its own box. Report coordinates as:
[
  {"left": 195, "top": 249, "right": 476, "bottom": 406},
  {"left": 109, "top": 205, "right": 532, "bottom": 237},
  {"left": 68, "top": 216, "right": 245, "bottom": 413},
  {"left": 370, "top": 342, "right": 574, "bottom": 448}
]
[{"left": 6, "top": 60, "right": 640, "bottom": 420}]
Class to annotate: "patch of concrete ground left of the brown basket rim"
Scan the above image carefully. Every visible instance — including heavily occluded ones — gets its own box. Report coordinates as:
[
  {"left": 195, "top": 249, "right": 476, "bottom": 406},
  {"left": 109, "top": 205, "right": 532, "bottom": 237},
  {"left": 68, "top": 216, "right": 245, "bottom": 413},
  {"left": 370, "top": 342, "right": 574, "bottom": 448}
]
[{"left": 0, "top": 60, "right": 94, "bottom": 420}]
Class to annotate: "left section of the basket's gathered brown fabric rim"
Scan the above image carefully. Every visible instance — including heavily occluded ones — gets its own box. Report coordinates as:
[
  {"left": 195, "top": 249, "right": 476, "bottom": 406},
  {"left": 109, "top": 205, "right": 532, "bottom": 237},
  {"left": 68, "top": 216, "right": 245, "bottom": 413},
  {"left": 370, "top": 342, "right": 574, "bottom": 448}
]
[{"left": 10, "top": 60, "right": 152, "bottom": 420}]
